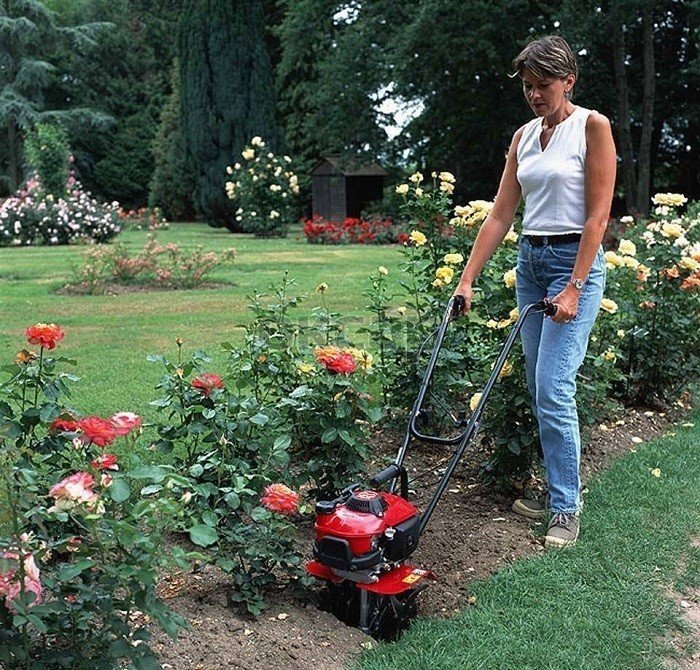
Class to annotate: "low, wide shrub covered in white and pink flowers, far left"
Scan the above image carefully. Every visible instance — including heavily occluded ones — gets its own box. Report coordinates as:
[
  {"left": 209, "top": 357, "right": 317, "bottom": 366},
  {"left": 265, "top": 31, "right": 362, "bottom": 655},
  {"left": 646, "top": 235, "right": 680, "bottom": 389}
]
[{"left": 0, "top": 177, "right": 121, "bottom": 246}]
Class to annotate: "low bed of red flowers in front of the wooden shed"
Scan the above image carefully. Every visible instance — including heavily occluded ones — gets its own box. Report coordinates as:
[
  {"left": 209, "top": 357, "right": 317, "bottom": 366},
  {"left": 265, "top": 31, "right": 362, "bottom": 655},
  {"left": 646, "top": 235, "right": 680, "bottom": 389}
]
[{"left": 304, "top": 216, "right": 408, "bottom": 244}]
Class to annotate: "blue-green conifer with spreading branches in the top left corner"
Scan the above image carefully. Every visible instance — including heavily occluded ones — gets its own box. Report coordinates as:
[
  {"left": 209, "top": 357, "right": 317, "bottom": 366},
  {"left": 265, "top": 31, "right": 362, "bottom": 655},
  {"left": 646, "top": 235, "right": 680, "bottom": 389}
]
[{"left": 0, "top": 0, "right": 106, "bottom": 190}]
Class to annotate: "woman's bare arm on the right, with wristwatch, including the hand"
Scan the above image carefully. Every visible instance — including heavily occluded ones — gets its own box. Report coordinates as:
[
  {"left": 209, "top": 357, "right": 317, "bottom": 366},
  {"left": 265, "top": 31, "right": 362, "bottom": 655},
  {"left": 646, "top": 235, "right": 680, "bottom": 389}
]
[{"left": 552, "top": 114, "right": 617, "bottom": 323}]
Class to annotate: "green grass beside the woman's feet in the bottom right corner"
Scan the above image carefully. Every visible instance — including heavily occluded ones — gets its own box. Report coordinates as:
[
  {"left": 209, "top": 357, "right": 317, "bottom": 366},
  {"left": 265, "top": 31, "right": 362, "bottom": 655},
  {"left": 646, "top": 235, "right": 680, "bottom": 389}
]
[{"left": 360, "top": 412, "right": 700, "bottom": 670}]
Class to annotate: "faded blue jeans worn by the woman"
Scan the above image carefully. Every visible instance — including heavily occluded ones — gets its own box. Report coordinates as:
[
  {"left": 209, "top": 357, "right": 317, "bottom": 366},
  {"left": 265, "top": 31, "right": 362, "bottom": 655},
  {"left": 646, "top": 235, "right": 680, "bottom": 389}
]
[{"left": 516, "top": 237, "right": 605, "bottom": 514}]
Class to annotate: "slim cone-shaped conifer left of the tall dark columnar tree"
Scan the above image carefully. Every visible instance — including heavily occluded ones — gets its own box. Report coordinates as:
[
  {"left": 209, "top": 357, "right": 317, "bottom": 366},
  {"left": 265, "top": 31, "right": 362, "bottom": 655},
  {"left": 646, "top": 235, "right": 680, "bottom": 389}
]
[{"left": 148, "top": 60, "right": 194, "bottom": 221}]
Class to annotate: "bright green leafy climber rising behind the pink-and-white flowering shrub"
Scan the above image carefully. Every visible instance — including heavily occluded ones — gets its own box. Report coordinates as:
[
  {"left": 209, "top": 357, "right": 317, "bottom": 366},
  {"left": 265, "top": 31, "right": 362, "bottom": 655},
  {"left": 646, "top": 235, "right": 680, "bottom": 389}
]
[{"left": 24, "top": 123, "right": 70, "bottom": 198}]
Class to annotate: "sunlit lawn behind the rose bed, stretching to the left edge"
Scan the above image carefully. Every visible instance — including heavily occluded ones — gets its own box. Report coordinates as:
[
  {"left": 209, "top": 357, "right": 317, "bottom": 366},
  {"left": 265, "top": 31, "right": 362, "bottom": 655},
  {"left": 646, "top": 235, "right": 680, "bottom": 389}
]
[{"left": 0, "top": 224, "right": 399, "bottom": 418}]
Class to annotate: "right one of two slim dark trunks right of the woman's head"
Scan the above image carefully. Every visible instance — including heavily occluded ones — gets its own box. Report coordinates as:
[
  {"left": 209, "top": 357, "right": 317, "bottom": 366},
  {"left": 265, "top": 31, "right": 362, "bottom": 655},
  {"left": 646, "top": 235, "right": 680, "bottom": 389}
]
[{"left": 636, "top": 8, "right": 656, "bottom": 215}]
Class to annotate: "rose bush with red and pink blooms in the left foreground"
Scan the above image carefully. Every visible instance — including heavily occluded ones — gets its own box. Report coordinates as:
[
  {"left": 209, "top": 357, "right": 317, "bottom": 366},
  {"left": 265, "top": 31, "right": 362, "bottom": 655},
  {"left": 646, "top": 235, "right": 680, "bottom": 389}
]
[{"left": 0, "top": 324, "right": 187, "bottom": 670}]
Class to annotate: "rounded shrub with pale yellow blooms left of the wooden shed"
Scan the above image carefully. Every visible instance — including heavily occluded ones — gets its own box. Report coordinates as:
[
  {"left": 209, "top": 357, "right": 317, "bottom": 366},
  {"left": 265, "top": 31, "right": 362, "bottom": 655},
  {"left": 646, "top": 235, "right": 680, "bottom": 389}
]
[{"left": 226, "top": 137, "right": 299, "bottom": 237}]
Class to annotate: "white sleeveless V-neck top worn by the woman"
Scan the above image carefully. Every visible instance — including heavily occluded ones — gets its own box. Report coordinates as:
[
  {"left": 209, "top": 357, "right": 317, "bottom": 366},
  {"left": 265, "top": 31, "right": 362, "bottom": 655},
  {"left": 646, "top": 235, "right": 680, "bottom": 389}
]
[{"left": 517, "top": 107, "right": 593, "bottom": 235}]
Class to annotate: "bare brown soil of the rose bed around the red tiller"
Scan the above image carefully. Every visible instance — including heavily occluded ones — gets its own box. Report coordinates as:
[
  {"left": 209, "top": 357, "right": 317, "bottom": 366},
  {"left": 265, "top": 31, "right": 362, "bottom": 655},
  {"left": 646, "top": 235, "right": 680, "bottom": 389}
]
[{"left": 154, "top": 402, "right": 697, "bottom": 670}]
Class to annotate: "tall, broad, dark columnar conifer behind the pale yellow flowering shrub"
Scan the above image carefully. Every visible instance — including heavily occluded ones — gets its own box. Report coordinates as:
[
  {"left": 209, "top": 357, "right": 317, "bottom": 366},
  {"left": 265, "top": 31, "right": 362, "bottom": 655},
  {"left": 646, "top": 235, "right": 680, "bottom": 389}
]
[{"left": 178, "top": 0, "right": 281, "bottom": 230}]
